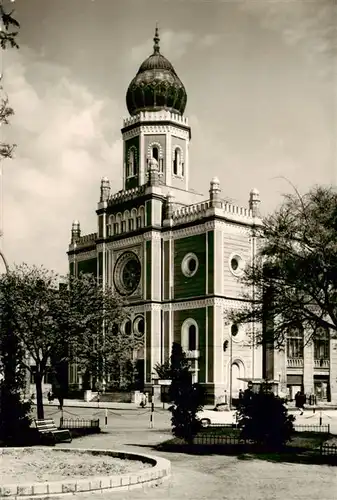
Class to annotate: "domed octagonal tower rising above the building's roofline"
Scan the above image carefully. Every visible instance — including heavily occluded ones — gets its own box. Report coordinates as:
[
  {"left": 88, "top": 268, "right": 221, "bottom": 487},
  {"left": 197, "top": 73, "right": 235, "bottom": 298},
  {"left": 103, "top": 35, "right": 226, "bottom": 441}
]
[{"left": 122, "top": 28, "right": 191, "bottom": 190}]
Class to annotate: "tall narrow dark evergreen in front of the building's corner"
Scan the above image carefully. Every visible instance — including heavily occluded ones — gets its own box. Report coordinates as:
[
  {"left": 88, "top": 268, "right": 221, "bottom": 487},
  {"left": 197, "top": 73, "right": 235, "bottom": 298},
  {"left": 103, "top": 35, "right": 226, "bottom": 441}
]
[{"left": 169, "top": 342, "right": 205, "bottom": 443}]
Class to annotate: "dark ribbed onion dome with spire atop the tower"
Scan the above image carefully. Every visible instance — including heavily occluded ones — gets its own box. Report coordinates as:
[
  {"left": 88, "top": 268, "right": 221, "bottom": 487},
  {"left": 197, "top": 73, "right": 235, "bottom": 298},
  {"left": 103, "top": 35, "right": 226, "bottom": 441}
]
[{"left": 126, "top": 27, "right": 187, "bottom": 115}]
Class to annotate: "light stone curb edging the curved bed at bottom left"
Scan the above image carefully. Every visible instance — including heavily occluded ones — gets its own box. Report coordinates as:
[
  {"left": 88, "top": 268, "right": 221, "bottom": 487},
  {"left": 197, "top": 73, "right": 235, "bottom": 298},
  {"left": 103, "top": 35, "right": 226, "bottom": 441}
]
[{"left": 0, "top": 447, "right": 171, "bottom": 500}]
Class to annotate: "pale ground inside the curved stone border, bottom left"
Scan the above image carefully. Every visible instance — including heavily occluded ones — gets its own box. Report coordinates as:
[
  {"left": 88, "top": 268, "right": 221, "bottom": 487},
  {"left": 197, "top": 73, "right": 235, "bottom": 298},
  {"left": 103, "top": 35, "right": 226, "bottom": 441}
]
[{"left": 0, "top": 448, "right": 152, "bottom": 484}]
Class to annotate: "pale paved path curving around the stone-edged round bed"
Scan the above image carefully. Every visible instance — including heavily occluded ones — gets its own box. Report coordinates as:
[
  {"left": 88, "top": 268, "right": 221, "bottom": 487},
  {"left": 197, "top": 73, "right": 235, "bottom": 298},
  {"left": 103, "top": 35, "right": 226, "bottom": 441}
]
[{"left": 47, "top": 407, "right": 337, "bottom": 500}]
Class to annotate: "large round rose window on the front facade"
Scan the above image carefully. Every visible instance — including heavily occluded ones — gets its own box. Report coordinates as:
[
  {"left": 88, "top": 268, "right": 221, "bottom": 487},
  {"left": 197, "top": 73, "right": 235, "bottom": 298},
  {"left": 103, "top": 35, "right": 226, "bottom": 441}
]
[{"left": 114, "top": 252, "right": 141, "bottom": 295}]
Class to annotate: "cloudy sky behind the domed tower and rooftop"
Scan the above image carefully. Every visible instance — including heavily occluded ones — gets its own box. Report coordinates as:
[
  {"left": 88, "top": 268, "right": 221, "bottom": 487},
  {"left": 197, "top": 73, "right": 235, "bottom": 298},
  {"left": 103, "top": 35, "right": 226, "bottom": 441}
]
[{"left": 1, "top": 0, "right": 337, "bottom": 274}]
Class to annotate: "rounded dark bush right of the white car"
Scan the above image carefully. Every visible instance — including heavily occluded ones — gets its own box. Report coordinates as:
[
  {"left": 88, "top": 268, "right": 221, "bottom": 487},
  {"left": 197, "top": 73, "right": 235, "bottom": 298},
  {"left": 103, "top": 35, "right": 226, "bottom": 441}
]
[{"left": 237, "top": 383, "right": 295, "bottom": 449}]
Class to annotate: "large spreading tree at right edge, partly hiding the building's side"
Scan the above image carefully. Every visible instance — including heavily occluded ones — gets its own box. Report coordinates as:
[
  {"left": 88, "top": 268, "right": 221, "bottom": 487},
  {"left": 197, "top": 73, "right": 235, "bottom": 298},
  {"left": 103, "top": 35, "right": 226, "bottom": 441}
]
[{"left": 229, "top": 187, "right": 337, "bottom": 347}]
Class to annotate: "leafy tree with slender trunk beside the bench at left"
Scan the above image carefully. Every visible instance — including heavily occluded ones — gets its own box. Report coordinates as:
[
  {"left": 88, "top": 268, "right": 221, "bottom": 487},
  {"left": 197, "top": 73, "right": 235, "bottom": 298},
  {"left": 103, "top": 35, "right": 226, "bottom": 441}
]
[{"left": 0, "top": 265, "right": 134, "bottom": 418}]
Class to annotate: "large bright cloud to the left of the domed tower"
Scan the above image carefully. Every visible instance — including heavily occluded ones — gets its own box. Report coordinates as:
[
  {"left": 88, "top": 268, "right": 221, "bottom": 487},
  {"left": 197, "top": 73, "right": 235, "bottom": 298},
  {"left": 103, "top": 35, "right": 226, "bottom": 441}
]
[{"left": 4, "top": 49, "right": 122, "bottom": 272}]
